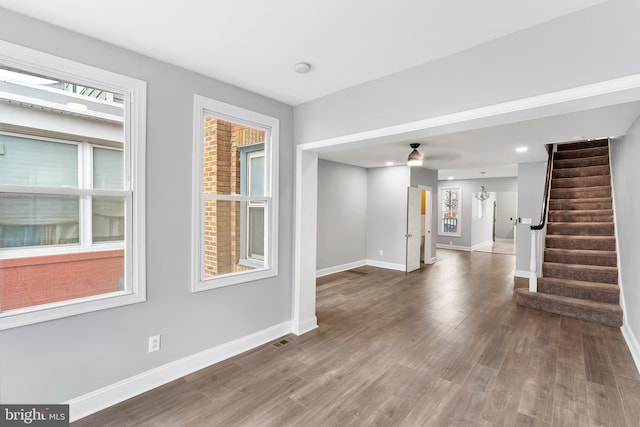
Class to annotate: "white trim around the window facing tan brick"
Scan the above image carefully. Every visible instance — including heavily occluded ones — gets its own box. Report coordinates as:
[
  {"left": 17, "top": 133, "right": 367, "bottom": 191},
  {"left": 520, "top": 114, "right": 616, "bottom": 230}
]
[{"left": 191, "top": 95, "right": 280, "bottom": 292}]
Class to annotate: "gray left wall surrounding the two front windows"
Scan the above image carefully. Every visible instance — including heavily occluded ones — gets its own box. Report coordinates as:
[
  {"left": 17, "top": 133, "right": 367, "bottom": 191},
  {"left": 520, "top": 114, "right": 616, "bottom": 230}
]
[{"left": 0, "top": 9, "right": 294, "bottom": 403}]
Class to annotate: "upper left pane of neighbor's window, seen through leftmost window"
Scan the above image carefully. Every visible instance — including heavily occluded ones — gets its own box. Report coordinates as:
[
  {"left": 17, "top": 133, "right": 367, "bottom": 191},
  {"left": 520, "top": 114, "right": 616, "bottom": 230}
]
[{"left": 0, "top": 134, "right": 78, "bottom": 187}]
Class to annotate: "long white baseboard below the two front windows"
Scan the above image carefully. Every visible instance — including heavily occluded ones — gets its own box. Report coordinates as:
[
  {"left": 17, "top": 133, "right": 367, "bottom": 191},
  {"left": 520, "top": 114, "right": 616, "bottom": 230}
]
[{"left": 65, "top": 321, "right": 291, "bottom": 422}]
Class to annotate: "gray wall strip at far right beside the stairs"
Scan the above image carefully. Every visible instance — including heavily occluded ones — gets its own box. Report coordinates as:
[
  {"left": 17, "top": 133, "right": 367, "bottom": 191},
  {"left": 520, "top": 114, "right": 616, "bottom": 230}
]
[{"left": 611, "top": 118, "right": 640, "bottom": 355}]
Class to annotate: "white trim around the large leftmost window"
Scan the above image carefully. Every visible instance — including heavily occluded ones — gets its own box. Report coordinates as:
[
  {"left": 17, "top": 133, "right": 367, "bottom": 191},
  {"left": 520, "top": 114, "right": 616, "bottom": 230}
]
[{"left": 0, "top": 40, "right": 147, "bottom": 330}]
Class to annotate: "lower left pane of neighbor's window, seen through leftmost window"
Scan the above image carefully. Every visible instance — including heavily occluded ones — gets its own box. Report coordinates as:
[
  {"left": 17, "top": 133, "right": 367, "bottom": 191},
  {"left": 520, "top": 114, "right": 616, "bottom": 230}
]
[{"left": 0, "top": 193, "right": 80, "bottom": 248}]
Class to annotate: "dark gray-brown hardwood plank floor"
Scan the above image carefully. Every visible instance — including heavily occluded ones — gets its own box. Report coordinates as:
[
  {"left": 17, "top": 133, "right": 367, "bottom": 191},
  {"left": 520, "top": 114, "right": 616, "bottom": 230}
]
[{"left": 73, "top": 250, "right": 640, "bottom": 427}]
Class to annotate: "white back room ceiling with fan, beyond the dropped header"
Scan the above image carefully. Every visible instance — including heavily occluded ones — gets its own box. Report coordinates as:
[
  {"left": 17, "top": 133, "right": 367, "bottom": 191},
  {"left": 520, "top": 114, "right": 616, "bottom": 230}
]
[{"left": 319, "top": 101, "right": 640, "bottom": 179}]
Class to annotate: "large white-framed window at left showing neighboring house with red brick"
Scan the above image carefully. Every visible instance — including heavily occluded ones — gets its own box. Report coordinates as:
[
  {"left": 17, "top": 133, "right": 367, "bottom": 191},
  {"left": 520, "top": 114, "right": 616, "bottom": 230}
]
[{"left": 0, "top": 42, "right": 146, "bottom": 329}]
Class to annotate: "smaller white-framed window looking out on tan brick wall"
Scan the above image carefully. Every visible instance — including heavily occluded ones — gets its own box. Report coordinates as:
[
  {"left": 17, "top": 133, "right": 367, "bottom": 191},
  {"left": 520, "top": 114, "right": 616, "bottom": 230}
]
[{"left": 192, "top": 96, "right": 278, "bottom": 291}]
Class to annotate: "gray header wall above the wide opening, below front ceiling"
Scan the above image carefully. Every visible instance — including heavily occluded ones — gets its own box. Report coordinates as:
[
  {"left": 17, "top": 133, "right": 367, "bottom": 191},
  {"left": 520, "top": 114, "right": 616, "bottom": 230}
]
[{"left": 294, "top": 0, "right": 640, "bottom": 143}]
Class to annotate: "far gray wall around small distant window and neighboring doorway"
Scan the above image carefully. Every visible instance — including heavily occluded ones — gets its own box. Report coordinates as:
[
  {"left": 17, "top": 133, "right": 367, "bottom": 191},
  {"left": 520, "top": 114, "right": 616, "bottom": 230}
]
[{"left": 435, "top": 178, "right": 518, "bottom": 248}]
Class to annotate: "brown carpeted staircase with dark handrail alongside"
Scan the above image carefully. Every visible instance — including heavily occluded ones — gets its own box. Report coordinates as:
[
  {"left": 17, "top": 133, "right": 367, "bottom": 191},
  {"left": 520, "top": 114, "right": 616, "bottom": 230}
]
[{"left": 516, "top": 139, "right": 622, "bottom": 327}]
